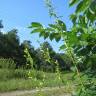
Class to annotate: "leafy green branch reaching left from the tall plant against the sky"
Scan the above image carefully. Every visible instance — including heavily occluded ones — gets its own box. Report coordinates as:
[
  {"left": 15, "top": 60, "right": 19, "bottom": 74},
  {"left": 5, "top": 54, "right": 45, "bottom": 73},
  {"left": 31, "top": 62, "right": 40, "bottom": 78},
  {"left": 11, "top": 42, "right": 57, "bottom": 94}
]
[{"left": 30, "top": 20, "right": 67, "bottom": 42}]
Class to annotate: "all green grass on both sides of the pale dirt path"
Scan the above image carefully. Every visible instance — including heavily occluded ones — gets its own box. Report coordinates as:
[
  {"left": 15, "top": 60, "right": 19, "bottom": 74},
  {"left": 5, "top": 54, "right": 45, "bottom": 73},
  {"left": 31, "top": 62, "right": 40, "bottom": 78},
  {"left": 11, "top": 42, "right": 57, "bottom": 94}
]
[{"left": 0, "top": 69, "right": 96, "bottom": 96}]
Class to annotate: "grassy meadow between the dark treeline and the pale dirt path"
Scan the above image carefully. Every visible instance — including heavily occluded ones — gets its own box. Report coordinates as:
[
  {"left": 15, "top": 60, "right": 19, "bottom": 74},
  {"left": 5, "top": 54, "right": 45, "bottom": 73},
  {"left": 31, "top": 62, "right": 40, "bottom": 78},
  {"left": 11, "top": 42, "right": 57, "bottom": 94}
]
[{"left": 0, "top": 69, "right": 72, "bottom": 92}]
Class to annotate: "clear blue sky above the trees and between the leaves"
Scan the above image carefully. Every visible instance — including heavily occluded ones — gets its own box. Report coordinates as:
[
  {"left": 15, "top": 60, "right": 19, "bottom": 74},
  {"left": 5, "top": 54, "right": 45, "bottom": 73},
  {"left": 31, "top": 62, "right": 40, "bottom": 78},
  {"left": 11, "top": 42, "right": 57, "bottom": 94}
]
[{"left": 0, "top": 0, "right": 75, "bottom": 51}]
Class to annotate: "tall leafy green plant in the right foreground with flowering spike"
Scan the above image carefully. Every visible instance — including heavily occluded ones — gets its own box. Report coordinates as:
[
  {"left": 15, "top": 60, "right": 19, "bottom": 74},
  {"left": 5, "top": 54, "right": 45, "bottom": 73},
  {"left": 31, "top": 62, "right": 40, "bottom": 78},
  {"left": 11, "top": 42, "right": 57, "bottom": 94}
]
[{"left": 30, "top": 0, "right": 96, "bottom": 96}]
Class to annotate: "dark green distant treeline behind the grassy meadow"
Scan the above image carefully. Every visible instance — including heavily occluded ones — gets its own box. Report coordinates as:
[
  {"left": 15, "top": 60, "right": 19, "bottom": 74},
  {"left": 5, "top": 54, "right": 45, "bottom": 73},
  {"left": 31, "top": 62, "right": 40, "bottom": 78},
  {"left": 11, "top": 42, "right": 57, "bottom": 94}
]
[{"left": 0, "top": 29, "right": 71, "bottom": 71}]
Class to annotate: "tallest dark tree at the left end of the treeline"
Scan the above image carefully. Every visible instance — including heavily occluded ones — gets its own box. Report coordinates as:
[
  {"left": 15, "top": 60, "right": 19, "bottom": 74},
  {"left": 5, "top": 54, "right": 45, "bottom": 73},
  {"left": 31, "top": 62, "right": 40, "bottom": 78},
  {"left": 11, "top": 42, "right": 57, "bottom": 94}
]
[{"left": 0, "top": 29, "right": 20, "bottom": 68}]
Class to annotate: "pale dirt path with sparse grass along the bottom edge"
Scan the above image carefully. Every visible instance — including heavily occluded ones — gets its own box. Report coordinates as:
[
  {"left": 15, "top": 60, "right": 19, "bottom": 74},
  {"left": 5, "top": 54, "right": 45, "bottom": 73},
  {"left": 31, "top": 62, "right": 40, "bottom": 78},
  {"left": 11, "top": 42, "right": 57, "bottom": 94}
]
[{"left": 0, "top": 87, "right": 71, "bottom": 96}]
